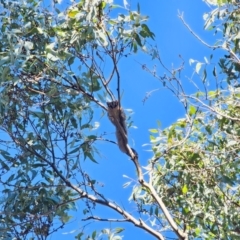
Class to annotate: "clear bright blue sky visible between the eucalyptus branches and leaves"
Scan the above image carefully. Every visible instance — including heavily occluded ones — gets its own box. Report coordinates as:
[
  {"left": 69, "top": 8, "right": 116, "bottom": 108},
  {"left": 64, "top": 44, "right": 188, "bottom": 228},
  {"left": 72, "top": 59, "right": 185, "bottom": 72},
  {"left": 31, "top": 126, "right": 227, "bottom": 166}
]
[{"left": 44, "top": 0, "right": 220, "bottom": 240}]
